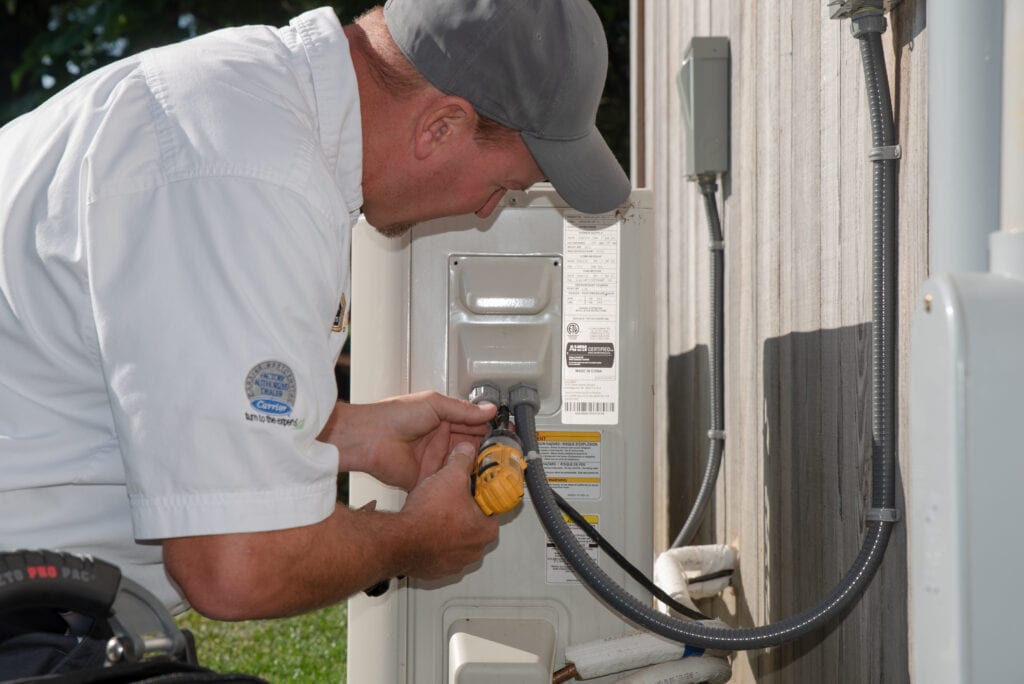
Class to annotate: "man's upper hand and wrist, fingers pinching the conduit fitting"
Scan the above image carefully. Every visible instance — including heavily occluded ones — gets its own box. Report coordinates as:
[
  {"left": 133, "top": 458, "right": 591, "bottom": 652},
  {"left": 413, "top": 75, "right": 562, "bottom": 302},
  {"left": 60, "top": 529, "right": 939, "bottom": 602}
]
[{"left": 318, "top": 392, "right": 496, "bottom": 491}]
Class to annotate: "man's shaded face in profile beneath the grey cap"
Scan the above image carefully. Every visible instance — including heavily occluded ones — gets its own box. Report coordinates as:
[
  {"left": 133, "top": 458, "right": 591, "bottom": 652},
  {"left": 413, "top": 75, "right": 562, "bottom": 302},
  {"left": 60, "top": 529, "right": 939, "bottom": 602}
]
[{"left": 368, "top": 135, "right": 544, "bottom": 238}]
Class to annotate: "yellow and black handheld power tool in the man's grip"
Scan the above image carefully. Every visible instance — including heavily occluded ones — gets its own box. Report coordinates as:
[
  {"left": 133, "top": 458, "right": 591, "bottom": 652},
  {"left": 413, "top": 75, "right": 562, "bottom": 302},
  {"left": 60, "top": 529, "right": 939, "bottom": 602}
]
[{"left": 472, "top": 405, "right": 526, "bottom": 515}]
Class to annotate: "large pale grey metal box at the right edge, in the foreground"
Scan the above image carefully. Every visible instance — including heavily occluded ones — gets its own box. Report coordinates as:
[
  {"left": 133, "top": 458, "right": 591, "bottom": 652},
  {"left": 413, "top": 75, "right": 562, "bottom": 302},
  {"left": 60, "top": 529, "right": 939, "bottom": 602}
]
[{"left": 906, "top": 268, "right": 1024, "bottom": 684}]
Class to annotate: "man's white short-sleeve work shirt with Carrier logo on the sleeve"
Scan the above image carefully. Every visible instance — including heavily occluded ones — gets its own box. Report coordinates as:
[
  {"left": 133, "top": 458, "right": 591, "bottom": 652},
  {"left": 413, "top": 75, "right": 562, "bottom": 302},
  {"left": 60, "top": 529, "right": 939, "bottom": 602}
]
[{"left": 0, "top": 8, "right": 362, "bottom": 609}]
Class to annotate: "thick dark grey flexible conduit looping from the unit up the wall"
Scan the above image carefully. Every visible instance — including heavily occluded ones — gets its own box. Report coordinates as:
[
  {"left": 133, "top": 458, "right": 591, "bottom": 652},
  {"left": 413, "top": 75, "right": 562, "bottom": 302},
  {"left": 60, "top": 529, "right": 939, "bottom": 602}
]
[{"left": 514, "top": 16, "right": 896, "bottom": 650}]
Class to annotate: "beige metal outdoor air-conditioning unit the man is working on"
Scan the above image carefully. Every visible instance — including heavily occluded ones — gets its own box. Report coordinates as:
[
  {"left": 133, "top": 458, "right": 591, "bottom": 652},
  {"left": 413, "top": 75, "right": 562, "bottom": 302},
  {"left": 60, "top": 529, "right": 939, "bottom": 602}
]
[{"left": 348, "top": 185, "right": 654, "bottom": 684}]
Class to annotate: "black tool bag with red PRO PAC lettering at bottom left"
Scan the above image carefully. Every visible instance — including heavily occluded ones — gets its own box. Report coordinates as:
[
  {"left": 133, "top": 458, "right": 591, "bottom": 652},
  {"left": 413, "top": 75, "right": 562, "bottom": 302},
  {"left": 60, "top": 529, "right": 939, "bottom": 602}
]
[{"left": 0, "top": 551, "right": 266, "bottom": 684}]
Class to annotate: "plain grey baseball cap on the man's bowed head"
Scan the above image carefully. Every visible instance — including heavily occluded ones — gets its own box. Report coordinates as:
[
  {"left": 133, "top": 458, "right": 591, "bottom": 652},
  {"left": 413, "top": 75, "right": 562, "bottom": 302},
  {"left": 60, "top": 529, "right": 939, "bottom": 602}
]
[{"left": 384, "top": 0, "right": 630, "bottom": 213}]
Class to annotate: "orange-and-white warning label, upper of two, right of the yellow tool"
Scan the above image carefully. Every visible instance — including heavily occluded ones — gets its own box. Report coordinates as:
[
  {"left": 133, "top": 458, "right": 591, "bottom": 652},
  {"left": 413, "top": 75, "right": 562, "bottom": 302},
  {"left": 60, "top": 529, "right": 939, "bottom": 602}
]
[{"left": 537, "top": 431, "right": 601, "bottom": 499}]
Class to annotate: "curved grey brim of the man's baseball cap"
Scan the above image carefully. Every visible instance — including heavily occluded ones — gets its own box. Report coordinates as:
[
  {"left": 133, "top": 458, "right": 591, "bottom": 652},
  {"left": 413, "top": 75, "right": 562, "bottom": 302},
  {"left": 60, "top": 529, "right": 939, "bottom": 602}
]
[{"left": 522, "top": 127, "right": 631, "bottom": 214}]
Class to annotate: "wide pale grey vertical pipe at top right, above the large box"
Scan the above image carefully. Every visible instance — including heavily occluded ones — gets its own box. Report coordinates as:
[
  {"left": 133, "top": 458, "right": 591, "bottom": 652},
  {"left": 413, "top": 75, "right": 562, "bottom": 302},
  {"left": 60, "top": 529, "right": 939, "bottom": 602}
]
[{"left": 928, "top": 0, "right": 999, "bottom": 275}]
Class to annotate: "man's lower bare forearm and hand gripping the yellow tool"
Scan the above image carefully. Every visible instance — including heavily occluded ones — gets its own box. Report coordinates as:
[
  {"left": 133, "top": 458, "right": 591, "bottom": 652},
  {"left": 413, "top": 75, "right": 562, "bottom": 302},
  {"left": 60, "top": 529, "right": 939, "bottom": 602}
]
[{"left": 164, "top": 442, "right": 499, "bottom": 619}]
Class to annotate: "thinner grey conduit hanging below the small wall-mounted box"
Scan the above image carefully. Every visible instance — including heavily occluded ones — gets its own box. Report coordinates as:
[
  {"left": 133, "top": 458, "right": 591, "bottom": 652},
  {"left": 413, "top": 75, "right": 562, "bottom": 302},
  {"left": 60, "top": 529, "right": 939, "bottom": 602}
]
[{"left": 672, "top": 176, "right": 725, "bottom": 547}]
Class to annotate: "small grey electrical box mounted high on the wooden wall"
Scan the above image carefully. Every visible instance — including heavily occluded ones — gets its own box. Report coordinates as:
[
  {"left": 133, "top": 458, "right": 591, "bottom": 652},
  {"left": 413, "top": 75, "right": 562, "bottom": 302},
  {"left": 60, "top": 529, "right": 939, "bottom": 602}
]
[{"left": 676, "top": 36, "right": 729, "bottom": 178}]
